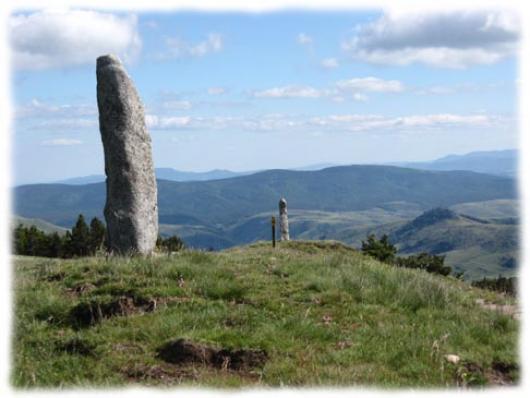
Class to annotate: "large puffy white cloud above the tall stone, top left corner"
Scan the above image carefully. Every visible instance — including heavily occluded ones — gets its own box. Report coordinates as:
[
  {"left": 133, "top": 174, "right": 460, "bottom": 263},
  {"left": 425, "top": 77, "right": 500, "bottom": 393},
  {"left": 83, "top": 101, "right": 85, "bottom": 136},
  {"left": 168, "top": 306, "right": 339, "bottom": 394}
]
[{"left": 9, "top": 10, "right": 141, "bottom": 69}]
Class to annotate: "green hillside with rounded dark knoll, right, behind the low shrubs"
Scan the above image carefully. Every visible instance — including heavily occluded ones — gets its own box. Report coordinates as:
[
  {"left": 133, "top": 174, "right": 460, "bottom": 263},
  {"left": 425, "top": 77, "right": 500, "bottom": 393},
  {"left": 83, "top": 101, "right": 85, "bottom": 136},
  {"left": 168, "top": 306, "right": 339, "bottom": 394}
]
[{"left": 342, "top": 208, "right": 519, "bottom": 280}]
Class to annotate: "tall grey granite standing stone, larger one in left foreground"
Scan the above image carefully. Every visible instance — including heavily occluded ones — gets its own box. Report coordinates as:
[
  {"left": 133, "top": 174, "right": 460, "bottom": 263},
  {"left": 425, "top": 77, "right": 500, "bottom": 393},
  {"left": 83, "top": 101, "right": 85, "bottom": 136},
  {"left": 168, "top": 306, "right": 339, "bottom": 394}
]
[{"left": 96, "top": 55, "right": 158, "bottom": 255}]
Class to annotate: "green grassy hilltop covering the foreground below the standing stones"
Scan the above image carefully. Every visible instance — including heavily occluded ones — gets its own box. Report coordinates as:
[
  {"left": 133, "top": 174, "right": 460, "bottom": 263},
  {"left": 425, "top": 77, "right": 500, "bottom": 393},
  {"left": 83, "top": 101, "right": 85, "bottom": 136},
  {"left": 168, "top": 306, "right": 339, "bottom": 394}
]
[{"left": 11, "top": 241, "right": 519, "bottom": 387}]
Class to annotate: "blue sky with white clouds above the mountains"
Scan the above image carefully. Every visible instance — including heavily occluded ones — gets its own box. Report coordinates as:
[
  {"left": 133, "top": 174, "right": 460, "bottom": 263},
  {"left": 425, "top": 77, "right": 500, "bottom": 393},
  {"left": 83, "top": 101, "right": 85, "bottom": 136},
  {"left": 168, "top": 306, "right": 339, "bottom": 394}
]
[{"left": 10, "top": 10, "right": 519, "bottom": 184}]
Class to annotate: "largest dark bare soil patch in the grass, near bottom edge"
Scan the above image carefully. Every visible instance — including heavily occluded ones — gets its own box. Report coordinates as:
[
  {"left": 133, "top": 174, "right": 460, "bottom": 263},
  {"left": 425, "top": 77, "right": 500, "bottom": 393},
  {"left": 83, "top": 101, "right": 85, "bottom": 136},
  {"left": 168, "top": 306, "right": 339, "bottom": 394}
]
[{"left": 157, "top": 339, "right": 268, "bottom": 371}]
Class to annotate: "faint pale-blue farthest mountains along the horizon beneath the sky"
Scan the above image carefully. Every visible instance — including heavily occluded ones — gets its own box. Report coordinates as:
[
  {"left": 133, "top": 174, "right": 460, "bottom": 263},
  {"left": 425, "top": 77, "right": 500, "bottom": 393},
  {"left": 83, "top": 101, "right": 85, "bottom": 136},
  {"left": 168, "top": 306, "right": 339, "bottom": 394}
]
[{"left": 43, "top": 149, "right": 518, "bottom": 185}]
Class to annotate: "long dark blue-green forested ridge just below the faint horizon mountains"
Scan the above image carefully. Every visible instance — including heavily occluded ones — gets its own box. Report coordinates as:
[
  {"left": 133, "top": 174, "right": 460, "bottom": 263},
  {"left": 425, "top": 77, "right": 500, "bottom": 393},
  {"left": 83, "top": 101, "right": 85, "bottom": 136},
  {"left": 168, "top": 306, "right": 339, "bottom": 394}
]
[{"left": 14, "top": 166, "right": 517, "bottom": 227}]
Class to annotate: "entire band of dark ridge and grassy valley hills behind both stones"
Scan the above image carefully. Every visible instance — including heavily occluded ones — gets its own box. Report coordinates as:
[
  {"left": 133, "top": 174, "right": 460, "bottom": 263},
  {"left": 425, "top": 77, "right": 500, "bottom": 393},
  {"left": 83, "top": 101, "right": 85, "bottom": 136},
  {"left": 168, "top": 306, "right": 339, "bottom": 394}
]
[{"left": 14, "top": 166, "right": 518, "bottom": 277}]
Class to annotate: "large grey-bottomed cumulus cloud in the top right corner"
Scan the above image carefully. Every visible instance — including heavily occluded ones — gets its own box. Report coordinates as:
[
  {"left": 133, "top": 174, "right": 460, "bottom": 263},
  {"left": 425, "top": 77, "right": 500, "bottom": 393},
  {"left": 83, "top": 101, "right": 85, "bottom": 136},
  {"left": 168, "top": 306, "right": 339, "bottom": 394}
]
[{"left": 342, "top": 11, "right": 519, "bottom": 68}]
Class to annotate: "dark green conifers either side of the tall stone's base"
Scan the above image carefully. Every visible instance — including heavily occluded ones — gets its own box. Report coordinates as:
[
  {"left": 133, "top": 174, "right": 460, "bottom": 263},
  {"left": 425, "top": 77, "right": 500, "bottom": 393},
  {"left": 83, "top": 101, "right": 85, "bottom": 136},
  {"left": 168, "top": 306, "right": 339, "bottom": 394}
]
[{"left": 13, "top": 214, "right": 185, "bottom": 258}]
